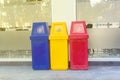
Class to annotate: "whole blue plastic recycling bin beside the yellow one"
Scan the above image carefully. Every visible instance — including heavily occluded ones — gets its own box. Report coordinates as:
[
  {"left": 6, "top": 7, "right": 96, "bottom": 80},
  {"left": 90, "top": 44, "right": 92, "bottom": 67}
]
[{"left": 30, "top": 22, "right": 49, "bottom": 70}]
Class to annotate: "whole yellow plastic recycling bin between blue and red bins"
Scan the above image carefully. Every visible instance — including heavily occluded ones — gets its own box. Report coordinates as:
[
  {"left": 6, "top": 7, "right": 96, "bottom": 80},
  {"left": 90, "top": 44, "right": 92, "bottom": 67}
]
[{"left": 49, "top": 22, "right": 68, "bottom": 70}]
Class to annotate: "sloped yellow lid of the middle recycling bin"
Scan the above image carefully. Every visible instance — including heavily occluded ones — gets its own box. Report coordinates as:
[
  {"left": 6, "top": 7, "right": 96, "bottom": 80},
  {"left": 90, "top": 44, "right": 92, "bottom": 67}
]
[{"left": 49, "top": 22, "right": 68, "bottom": 39}]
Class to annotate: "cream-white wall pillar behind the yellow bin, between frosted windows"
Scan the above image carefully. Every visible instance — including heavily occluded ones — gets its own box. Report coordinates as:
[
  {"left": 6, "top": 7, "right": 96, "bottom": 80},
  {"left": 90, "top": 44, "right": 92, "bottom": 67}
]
[{"left": 51, "top": 0, "right": 76, "bottom": 33}]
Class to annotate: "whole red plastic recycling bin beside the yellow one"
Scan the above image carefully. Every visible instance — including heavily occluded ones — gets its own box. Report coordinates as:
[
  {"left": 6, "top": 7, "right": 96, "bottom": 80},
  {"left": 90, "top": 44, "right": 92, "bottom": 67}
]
[{"left": 69, "top": 21, "right": 88, "bottom": 70}]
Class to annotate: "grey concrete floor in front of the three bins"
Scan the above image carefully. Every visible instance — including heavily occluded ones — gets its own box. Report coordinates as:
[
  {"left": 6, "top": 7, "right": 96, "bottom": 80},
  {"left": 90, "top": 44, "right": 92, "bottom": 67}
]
[{"left": 0, "top": 66, "right": 120, "bottom": 80}]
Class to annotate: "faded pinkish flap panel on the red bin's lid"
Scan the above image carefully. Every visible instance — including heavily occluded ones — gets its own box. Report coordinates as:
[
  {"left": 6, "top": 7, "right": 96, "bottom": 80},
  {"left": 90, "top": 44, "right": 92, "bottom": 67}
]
[{"left": 72, "top": 24, "right": 85, "bottom": 33}]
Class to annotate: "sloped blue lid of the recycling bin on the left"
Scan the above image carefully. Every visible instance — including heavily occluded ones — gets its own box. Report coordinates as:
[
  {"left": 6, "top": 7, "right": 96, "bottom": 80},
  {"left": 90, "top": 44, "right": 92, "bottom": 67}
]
[{"left": 30, "top": 22, "right": 49, "bottom": 39}]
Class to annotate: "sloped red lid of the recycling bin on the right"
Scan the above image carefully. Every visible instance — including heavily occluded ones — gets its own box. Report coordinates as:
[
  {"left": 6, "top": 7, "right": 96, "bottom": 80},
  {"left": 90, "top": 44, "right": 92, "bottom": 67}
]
[{"left": 69, "top": 21, "right": 88, "bottom": 39}]
